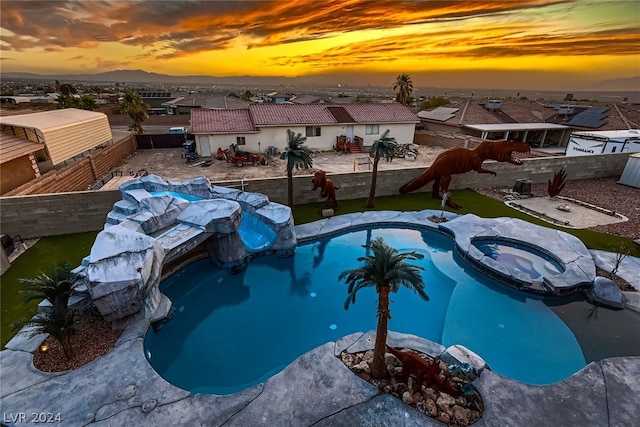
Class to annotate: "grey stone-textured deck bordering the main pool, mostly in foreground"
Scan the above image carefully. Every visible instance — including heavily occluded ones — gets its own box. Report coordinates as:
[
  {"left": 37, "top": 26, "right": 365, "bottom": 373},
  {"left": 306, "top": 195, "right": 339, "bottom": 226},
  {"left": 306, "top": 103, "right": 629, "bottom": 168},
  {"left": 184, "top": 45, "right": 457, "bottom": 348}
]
[{"left": 0, "top": 211, "right": 640, "bottom": 427}]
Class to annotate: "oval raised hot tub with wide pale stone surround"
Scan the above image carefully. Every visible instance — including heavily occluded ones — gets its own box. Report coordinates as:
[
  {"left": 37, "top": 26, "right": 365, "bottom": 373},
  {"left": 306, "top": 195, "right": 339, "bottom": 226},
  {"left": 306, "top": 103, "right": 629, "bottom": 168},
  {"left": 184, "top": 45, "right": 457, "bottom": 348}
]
[{"left": 440, "top": 214, "right": 596, "bottom": 295}]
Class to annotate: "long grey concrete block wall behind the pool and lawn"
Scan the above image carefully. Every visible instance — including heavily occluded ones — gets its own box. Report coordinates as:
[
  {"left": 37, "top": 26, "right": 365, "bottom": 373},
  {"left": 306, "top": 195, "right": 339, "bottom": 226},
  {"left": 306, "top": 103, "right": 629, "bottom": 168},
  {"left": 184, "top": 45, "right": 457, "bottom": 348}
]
[{"left": 0, "top": 154, "right": 629, "bottom": 238}]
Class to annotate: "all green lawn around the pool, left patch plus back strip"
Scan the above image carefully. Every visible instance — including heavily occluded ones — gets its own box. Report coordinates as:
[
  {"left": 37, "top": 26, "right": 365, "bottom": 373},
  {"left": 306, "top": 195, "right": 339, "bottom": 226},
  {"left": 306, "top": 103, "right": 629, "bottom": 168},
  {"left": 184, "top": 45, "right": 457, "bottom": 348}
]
[{"left": 0, "top": 190, "right": 640, "bottom": 346}]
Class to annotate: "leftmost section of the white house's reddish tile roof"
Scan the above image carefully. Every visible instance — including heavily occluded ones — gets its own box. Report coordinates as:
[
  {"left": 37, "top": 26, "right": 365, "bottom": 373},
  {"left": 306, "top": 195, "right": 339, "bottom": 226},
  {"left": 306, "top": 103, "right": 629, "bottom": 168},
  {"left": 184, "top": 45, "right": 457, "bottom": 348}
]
[{"left": 191, "top": 108, "right": 258, "bottom": 133}]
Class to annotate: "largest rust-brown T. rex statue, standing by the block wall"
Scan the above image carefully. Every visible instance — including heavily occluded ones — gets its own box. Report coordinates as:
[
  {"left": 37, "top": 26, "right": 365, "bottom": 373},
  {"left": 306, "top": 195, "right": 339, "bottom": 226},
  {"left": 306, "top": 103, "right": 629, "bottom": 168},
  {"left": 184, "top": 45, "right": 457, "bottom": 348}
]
[{"left": 400, "top": 140, "right": 530, "bottom": 209}]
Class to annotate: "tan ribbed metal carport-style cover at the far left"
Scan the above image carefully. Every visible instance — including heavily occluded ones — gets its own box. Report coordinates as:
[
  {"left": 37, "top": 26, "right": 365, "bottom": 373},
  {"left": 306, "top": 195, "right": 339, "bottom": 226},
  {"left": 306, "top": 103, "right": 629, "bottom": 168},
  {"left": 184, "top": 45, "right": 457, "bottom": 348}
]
[{"left": 0, "top": 108, "right": 113, "bottom": 172}]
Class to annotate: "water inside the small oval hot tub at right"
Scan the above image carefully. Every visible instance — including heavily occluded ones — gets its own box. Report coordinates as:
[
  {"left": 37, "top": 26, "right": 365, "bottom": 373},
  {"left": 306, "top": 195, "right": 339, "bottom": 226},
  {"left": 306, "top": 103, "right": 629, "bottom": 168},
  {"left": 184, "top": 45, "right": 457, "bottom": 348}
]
[{"left": 473, "top": 239, "right": 564, "bottom": 280}]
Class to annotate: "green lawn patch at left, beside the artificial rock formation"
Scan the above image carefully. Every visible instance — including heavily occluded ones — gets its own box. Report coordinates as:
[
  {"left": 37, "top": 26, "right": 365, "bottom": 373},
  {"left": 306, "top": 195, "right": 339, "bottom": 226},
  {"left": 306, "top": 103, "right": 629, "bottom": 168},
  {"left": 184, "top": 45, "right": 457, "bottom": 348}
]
[{"left": 0, "top": 231, "right": 98, "bottom": 347}]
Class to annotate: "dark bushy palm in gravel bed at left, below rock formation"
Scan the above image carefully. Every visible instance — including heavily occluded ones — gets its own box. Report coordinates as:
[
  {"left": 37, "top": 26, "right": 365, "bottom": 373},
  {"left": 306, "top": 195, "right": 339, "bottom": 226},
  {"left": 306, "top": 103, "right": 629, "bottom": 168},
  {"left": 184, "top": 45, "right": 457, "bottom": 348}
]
[{"left": 15, "top": 264, "right": 77, "bottom": 359}]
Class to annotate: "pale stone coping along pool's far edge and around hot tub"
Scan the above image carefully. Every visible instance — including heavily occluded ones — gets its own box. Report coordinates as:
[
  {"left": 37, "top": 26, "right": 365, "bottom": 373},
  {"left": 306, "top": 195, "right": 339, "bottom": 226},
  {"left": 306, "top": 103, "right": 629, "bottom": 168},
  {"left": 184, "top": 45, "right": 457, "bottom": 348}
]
[{"left": 296, "top": 210, "right": 596, "bottom": 295}]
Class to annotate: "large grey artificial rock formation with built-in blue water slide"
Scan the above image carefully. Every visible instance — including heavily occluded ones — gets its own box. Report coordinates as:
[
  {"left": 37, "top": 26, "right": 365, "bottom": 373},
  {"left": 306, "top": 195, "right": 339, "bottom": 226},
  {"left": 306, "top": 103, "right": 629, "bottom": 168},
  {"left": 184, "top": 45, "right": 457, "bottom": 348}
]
[{"left": 78, "top": 175, "right": 297, "bottom": 324}]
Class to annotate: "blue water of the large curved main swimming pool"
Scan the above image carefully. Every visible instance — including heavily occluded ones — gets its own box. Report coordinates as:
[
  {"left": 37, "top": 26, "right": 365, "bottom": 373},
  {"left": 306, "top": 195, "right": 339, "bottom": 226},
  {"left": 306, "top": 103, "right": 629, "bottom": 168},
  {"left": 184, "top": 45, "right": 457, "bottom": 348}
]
[{"left": 145, "top": 228, "right": 585, "bottom": 394}]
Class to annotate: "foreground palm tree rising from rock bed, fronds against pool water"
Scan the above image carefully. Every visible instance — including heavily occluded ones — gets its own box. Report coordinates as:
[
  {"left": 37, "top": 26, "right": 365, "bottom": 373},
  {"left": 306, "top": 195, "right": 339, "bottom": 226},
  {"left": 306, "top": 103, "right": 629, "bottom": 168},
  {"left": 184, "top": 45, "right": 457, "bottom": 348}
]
[{"left": 338, "top": 237, "right": 429, "bottom": 378}]
